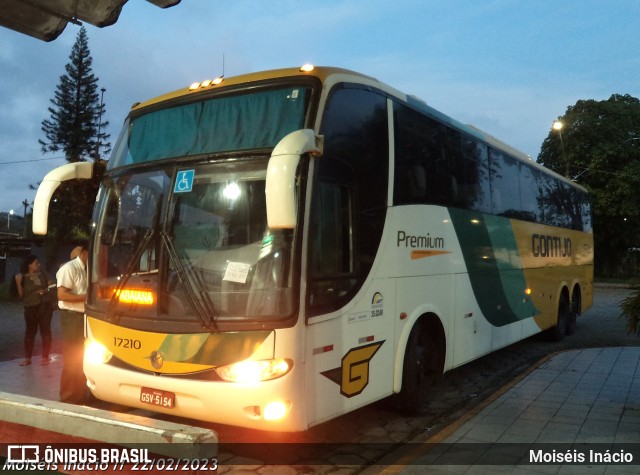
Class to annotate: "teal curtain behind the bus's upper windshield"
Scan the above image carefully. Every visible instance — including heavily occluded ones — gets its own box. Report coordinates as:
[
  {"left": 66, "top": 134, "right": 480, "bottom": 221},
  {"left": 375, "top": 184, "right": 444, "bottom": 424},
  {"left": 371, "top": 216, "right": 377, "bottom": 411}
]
[{"left": 125, "top": 88, "right": 306, "bottom": 166}]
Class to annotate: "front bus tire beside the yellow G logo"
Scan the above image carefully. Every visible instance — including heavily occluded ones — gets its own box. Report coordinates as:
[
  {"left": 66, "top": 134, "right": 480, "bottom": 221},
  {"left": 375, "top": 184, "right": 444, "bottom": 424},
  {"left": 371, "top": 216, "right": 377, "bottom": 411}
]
[{"left": 398, "top": 324, "right": 431, "bottom": 414}]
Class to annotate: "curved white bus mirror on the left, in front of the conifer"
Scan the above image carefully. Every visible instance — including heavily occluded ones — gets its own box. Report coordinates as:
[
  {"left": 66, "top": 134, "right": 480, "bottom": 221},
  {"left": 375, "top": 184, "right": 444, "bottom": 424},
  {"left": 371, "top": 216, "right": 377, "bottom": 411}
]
[{"left": 32, "top": 162, "right": 93, "bottom": 234}]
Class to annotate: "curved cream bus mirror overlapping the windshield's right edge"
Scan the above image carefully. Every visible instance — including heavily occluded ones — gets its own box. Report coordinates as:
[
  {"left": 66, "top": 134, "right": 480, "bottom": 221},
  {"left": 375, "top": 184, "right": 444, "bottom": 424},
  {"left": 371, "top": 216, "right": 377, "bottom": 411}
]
[{"left": 265, "top": 129, "right": 323, "bottom": 229}]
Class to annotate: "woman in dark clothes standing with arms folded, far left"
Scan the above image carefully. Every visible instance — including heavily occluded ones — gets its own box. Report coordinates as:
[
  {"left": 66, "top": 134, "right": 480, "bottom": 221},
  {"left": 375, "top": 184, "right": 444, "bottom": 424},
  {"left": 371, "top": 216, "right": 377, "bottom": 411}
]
[{"left": 15, "top": 255, "right": 53, "bottom": 366}]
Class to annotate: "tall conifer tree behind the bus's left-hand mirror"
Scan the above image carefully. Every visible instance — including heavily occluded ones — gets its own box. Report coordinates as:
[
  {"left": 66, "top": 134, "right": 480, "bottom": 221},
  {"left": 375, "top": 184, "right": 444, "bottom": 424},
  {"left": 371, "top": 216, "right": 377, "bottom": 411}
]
[{"left": 39, "top": 27, "right": 111, "bottom": 249}]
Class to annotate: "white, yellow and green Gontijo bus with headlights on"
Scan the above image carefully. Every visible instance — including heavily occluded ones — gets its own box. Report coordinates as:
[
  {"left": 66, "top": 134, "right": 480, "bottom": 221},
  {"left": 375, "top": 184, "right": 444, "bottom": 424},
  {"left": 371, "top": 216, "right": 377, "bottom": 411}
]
[{"left": 33, "top": 66, "right": 593, "bottom": 432}]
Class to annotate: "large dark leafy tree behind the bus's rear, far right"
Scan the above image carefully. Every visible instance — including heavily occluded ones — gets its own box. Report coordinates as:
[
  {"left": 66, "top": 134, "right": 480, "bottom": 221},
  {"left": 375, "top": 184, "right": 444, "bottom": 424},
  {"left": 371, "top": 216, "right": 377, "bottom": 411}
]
[{"left": 538, "top": 94, "right": 640, "bottom": 276}]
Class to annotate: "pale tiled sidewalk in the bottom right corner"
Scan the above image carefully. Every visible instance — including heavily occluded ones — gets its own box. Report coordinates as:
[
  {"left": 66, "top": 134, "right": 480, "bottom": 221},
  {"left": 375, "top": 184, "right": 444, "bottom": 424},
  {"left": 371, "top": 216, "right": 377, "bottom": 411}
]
[{"left": 376, "top": 347, "right": 640, "bottom": 475}]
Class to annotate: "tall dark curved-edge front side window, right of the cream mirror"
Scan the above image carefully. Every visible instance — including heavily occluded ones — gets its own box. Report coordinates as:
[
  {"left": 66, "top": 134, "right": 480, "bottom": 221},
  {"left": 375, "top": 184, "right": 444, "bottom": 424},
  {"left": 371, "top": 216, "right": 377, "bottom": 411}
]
[{"left": 307, "top": 84, "right": 389, "bottom": 316}]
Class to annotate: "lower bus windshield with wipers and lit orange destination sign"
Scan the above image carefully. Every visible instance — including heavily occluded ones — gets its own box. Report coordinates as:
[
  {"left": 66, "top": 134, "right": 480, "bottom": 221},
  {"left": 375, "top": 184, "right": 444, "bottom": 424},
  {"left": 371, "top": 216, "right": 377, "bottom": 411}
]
[{"left": 90, "top": 159, "right": 293, "bottom": 329}]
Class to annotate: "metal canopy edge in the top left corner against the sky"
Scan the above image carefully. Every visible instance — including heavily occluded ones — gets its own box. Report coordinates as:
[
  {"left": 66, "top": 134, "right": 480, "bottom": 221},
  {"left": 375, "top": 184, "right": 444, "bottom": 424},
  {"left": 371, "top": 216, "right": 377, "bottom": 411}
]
[{"left": 0, "top": 0, "right": 180, "bottom": 41}]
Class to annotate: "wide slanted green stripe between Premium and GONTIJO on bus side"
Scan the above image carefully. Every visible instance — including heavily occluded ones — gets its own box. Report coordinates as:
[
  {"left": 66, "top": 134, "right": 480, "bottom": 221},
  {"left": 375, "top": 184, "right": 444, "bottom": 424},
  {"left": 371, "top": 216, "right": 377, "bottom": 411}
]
[{"left": 449, "top": 208, "right": 539, "bottom": 327}]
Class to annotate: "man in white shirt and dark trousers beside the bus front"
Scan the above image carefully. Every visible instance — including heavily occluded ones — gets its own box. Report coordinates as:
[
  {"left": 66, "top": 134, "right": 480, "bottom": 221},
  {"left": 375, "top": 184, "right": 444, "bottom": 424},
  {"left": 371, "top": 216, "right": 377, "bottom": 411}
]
[{"left": 56, "top": 245, "right": 89, "bottom": 404}]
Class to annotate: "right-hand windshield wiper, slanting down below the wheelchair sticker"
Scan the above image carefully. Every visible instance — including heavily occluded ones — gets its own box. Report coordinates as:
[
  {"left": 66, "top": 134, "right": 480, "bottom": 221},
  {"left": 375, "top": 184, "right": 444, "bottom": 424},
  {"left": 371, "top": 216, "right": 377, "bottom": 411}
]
[{"left": 160, "top": 231, "right": 218, "bottom": 330}]
